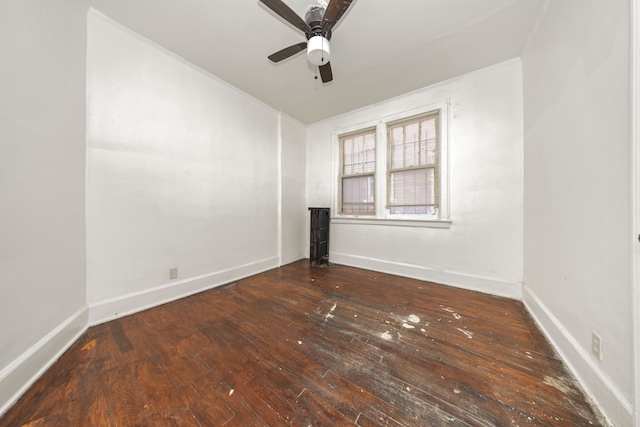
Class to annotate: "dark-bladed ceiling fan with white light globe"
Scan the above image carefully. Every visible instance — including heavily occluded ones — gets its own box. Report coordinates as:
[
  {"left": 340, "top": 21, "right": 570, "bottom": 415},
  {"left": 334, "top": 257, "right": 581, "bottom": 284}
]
[{"left": 260, "top": 0, "right": 353, "bottom": 83}]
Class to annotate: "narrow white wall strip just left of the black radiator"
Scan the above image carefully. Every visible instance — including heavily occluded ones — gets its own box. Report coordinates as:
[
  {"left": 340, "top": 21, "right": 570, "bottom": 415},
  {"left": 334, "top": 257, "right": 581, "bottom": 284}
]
[{"left": 280, "top": 114, "right": 308, "bottom": 265}]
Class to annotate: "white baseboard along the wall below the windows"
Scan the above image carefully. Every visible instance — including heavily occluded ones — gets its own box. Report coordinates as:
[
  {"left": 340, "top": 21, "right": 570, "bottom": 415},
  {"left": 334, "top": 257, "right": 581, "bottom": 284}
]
[{"left": 330, "top": 252, "right": 522, "bottom": 300}]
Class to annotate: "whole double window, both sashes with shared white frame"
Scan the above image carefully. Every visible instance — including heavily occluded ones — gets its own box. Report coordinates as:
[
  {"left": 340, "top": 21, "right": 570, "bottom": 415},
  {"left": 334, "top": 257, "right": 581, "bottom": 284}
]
[{"left": 332, "top": 101, "right": 451, "bottom": 228}]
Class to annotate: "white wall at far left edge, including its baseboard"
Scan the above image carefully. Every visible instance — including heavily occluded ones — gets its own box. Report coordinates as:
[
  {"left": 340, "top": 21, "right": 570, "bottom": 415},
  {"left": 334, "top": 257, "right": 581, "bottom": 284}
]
[{"left": 0, "top": 0, "right": 87, "bottom": 414}]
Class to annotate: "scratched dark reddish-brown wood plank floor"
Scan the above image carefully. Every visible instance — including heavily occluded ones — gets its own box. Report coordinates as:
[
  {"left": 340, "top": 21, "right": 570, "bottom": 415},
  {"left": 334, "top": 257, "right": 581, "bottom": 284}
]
[{"left": 0, "top": 261, "right": 605, "bottom": 426}]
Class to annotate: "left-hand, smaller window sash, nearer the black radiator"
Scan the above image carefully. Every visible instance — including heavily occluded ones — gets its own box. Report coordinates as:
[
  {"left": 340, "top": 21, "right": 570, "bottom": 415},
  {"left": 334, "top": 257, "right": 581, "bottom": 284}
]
[{"left": 340, "top": 129, "right": 376, "bottom": 214}]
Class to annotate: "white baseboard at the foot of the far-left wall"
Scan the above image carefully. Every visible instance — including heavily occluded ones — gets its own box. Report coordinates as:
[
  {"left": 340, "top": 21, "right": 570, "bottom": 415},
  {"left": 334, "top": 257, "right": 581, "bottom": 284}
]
[{"left": 0, "top": 306, "right": 89, "bottom": 416}]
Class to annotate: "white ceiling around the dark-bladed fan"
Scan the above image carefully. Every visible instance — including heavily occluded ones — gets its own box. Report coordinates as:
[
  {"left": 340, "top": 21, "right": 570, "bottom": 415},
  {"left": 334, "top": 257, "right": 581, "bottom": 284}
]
[{"left": 89, "top": 0, "right": 544, "bottom": 123}]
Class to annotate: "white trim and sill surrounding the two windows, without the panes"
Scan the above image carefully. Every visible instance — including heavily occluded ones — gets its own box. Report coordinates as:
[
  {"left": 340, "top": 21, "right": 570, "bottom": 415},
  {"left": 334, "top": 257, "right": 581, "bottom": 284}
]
[{"left": 331, "top": 99, "right": 451, "bottom": 228}]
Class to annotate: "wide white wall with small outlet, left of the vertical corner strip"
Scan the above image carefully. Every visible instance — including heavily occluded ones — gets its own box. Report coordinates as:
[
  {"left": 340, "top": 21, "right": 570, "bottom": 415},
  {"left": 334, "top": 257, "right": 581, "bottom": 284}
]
[{"left": 87, "top": 11, "right": 278, "bottom": 322}]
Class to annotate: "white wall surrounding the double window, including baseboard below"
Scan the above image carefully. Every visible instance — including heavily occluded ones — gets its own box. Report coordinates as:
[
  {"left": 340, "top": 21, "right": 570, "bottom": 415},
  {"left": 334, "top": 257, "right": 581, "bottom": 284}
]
[{"left": 307, "top": 60, "right": 523, "bottom": 298}]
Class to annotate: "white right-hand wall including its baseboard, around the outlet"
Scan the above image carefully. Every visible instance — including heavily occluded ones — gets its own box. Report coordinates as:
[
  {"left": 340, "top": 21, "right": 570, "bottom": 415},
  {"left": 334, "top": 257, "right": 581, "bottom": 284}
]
[{"left": 523, "top": 0, "right": 633, "bottom": 426}]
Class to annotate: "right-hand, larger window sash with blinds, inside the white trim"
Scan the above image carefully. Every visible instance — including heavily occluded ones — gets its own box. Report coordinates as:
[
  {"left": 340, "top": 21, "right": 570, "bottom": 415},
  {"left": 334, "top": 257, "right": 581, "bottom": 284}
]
[{"left": 387, "top": 111, "right": 440, "bottom": 215}]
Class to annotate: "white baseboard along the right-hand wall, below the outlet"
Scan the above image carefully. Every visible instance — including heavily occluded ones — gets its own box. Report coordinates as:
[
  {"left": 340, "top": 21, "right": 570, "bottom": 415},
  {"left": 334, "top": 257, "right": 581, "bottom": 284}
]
[{"left": 522, "top": 286, "right": 633, "bottom": 427}]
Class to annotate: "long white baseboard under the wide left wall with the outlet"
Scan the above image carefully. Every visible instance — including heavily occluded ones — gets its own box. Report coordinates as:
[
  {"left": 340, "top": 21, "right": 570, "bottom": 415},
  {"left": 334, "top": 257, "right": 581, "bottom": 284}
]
[{"left": 89, "top": 257, "right": 278, "bottom": 326}]
